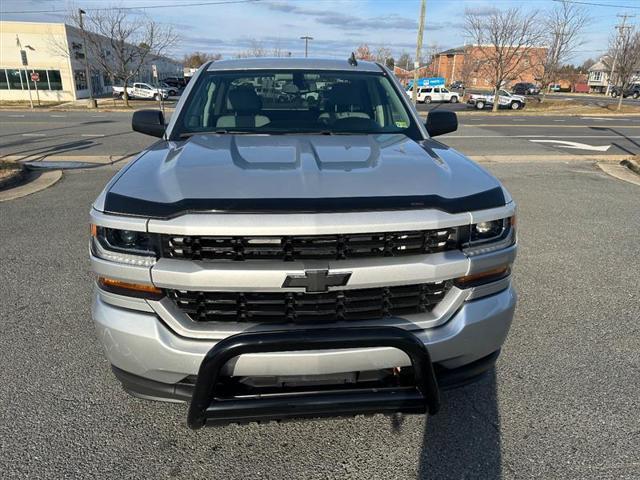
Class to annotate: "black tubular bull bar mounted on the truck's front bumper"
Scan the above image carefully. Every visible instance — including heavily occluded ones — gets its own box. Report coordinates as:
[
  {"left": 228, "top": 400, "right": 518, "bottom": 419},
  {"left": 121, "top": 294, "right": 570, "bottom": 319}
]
[{"left": 188, "top": 327, "right": 440, "bottom": 429}]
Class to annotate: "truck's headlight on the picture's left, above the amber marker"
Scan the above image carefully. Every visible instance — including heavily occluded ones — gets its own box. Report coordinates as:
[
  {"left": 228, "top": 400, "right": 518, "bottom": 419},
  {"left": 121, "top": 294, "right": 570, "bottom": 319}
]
[{"left": 91, "top": 225, "right": 159, "bottom": 267}]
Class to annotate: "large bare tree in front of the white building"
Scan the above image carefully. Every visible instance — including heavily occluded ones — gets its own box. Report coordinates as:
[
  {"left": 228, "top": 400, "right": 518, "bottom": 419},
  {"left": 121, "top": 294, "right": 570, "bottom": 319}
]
[{"left": 69, "top": 7, "right": 178, "bottom": 107}]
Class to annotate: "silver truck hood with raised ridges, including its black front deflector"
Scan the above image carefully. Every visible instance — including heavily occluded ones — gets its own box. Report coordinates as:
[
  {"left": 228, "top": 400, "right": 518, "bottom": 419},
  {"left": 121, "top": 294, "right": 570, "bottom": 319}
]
[{"left": 104, "top": 134, "right": 505, "bottom": 218}]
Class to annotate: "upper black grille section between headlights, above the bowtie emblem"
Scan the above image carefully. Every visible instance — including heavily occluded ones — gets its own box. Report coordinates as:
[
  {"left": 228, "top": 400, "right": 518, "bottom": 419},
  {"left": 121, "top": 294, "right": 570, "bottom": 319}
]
[{"left": 162, "top": 228, "right": 457, "bottom": 261}]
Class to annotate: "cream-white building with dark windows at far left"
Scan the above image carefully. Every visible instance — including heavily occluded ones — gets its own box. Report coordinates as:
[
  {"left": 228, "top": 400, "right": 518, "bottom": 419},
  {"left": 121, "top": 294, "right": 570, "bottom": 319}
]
[{"left": 0, "top": 21, "right": 182, "bottom": 101}]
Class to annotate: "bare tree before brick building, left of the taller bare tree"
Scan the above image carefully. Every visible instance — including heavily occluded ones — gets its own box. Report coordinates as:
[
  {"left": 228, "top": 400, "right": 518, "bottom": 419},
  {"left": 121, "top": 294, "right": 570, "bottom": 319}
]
[{"left": 465, "top": 8, "right": 543, "bottom": 111}]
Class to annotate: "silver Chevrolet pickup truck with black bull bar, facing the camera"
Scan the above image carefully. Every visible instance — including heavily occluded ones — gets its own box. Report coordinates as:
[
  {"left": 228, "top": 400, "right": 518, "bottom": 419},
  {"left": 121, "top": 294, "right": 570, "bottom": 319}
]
[{"left": 91, "top": 57, "right": 516, "bottom": 428}]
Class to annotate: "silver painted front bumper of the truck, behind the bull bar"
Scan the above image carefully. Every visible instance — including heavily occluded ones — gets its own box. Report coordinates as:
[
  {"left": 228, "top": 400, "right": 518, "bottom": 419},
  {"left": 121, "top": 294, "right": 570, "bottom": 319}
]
[{"left": 92, "top": 279, "right": 516, "bottom": 384}]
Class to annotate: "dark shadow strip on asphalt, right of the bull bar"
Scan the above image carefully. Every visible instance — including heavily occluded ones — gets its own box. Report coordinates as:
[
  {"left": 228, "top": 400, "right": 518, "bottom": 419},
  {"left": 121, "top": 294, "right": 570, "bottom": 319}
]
[{"left": 418, "top": 370, "right": 502, "bottom": 480}]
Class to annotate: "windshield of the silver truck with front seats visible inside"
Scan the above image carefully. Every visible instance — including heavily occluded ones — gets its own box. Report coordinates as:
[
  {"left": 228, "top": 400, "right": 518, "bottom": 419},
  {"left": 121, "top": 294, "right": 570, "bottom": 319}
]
[{"left": 172, "top": 70, "right": 422, "bottom": 140}]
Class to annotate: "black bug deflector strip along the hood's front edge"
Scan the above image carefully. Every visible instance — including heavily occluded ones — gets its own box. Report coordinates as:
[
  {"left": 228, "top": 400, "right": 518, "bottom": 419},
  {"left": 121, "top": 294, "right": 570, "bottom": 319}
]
[{"left": 104, "top": 187, "right": 505, "bottom": 219}]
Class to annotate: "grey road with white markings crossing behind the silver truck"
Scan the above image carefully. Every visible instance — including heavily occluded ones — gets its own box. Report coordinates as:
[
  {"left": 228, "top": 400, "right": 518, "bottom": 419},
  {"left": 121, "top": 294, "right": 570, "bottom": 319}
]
[{"left": 0, "top": 110, "right": 640, "bottom": 161}]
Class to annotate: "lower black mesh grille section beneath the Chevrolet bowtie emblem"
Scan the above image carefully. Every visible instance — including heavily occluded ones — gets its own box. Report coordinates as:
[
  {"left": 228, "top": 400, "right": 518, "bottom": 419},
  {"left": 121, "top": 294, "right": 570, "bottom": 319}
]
[{"left": 167, "top": 282, "right": 451, "bottom": 323}]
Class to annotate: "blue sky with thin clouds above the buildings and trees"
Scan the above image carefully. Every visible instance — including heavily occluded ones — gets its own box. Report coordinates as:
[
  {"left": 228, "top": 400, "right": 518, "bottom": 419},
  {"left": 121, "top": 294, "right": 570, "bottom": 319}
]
[{"left": 0, "top": 0, "right": 640, "bottom": 64}]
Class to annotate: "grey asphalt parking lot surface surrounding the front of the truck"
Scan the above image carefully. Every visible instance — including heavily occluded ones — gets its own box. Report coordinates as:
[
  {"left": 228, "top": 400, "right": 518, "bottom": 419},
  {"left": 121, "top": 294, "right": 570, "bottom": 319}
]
[{"left": 0, "top": 160, "right": 640, "bottom": 480}]
